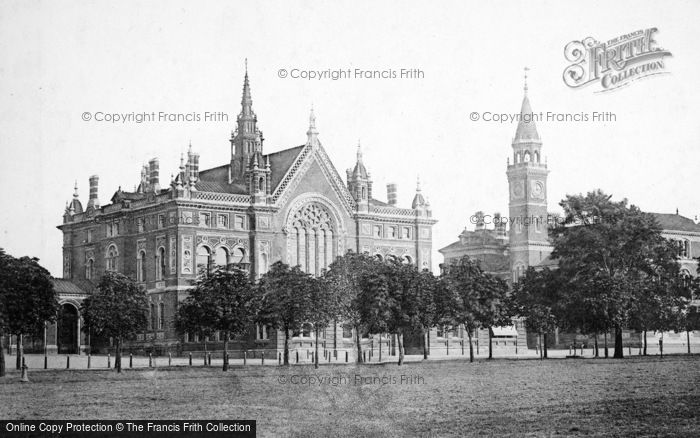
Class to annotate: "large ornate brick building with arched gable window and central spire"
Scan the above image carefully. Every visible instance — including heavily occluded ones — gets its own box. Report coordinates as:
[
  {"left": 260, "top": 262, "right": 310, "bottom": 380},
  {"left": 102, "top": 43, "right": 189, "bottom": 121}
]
[{"left": 30, "top": 66, "right": 437, "bottom": 357}]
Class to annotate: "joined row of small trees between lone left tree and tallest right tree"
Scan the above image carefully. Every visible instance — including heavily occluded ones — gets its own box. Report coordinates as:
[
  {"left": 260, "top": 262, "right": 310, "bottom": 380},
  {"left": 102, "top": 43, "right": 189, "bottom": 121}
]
[{"left": 175, "top": 252, "right": 509, "bottom": 369}]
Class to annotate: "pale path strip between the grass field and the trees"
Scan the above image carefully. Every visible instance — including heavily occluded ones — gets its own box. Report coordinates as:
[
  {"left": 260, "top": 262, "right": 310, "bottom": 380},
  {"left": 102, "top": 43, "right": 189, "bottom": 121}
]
[{"left": 5, "top": 344, "right": 700, "bottom": 371}]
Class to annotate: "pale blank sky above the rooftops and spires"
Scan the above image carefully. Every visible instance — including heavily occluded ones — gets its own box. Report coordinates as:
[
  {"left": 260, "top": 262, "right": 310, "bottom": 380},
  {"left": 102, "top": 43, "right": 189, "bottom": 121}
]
[{"left": 0, "top": 0, "right": 700, "bottom": 276}]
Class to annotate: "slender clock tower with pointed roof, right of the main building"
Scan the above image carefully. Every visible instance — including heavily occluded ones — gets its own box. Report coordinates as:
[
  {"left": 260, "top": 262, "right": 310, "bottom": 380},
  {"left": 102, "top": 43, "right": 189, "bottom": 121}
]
[{"left": 506, "top": 69, "right": 552, "bottom": 281}]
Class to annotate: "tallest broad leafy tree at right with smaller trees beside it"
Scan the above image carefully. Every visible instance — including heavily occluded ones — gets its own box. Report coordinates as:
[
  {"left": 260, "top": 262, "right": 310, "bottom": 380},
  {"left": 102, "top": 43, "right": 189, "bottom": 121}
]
[{"left": 510, "top": 190, "right": 700, "bottom": 358}]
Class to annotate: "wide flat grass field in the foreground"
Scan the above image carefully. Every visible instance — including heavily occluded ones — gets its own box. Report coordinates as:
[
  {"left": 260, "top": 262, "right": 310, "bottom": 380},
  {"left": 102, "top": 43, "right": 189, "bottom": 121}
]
[{"left": 0, "top": 355, "right": 700, "bottom": 437}]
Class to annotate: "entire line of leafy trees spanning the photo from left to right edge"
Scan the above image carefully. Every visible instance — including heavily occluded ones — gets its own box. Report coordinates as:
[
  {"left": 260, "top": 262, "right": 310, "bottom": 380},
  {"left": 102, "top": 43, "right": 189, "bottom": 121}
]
[{"left": 0, "top": 191, "right": 700, "bottom": 375}]
